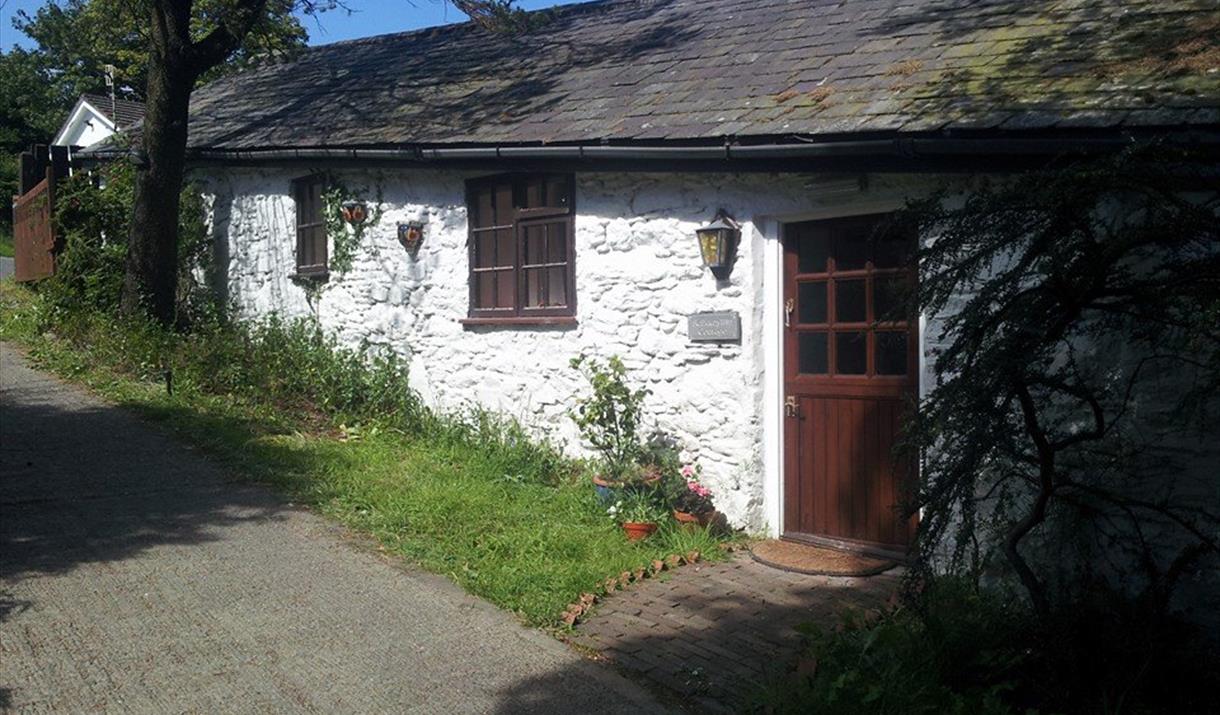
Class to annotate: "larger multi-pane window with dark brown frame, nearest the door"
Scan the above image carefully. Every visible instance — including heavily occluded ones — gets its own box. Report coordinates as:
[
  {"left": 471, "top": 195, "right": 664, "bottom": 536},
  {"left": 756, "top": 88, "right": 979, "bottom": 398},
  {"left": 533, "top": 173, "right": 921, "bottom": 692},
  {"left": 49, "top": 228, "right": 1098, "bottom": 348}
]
[{"left": 466, "top": 174, "right": 576, "bottom": 323}]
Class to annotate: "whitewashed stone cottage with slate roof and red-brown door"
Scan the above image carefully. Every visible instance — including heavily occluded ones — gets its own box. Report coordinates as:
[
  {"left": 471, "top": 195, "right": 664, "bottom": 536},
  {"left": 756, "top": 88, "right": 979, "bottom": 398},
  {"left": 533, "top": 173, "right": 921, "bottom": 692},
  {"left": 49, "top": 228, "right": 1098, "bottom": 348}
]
[{"left": 97, "top": 0, "right": 1220, "bottom": 552}]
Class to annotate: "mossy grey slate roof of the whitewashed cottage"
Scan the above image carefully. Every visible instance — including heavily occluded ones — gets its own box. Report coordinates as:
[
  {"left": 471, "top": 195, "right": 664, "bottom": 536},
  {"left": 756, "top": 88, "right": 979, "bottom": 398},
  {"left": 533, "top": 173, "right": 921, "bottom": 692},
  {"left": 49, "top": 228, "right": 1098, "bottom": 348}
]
[{"left": 190, "top": 0, "right": 1220, "bottom": 150}]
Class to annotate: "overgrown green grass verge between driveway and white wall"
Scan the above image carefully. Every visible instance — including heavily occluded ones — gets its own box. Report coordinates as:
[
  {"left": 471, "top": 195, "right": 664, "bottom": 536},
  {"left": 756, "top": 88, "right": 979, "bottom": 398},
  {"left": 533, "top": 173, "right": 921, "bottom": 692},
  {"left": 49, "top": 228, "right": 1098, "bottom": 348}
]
[{"left": 0, "top": 279, "right": 721, "bottom": 626}]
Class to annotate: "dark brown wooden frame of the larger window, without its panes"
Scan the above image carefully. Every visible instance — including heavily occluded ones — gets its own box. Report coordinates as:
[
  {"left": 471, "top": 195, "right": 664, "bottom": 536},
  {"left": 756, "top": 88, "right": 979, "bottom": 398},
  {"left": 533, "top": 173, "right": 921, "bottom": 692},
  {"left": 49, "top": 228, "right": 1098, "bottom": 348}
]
[{"left": 461, "top": 172, "right": 577, "bottom": 326}]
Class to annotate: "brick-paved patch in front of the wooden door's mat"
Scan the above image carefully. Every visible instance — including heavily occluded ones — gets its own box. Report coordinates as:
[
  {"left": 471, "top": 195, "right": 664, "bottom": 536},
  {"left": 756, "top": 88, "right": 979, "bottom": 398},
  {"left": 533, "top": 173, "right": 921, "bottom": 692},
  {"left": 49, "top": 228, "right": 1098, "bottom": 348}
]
[{"left": 572, "top": 554, "right": 899, "bottom": 710}]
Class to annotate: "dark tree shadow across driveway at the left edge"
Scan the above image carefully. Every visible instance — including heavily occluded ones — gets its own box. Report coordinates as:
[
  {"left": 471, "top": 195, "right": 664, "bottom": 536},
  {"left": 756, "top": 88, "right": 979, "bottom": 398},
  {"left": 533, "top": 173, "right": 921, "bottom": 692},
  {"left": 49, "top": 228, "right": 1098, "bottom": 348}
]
[{"left": 0, "top": 399, "right": 296, "bottom": 585}]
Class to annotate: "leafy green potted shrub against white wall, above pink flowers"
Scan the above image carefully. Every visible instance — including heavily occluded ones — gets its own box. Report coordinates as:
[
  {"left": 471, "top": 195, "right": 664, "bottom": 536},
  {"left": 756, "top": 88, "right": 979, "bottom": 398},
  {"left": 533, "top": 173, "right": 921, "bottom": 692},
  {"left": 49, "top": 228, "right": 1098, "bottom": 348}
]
[{"left": 571, "top": 355, "right": 648, "bottom": 481}]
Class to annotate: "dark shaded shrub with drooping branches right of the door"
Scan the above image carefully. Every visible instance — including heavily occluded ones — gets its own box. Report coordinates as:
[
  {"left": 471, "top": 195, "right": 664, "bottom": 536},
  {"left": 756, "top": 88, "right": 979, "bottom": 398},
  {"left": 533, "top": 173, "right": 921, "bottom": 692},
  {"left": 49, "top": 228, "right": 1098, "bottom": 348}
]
[{"left": 905, "top": 145, "right": 1220, "bottom": 614}]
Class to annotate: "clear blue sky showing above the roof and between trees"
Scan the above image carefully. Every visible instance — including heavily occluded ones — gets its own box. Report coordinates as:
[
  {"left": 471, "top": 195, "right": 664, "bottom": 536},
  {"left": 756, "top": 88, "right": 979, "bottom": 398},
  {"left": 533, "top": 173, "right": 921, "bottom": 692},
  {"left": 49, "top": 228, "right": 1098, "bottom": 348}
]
[{"left": 0, "top": 0, "right": 590, "bottom": 51}]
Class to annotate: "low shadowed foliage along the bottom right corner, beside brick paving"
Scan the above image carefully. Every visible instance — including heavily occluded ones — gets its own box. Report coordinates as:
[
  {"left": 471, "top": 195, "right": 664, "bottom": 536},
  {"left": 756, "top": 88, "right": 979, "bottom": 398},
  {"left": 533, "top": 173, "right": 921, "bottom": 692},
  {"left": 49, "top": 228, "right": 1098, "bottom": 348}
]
[{"left": 749, "top": 577, "right": 1220, "bottom": 715}]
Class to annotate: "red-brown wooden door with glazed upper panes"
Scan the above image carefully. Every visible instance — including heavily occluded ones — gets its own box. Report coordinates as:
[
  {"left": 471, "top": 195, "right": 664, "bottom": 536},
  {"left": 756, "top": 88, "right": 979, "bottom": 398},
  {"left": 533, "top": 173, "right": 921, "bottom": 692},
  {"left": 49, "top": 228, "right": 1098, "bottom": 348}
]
[{"left": 783, "top": 215, "right": 919, "bottom": 552}]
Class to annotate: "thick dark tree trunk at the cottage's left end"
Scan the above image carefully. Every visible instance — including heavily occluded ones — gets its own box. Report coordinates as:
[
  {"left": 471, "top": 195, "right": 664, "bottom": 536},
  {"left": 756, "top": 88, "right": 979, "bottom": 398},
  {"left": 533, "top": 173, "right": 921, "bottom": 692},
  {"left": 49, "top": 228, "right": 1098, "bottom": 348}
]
[{"left": 122, "top": 50, "right": 195, "bottom": 325}]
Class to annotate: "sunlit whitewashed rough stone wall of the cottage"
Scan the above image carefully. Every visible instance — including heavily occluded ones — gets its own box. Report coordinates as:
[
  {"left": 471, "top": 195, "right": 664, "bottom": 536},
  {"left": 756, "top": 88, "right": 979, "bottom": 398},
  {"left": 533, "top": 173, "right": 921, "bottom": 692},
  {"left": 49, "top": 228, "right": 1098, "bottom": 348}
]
[{"left": 201, "top": 170, "right": 917, "bottom": 528}]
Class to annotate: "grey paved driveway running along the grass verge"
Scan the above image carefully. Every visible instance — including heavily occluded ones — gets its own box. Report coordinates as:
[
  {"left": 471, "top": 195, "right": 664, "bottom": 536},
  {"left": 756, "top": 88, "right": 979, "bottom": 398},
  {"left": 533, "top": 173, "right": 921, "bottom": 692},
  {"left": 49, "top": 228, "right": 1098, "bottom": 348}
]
[{"left": 0, "top": 345, "right": 658, "bottom": 713}]
